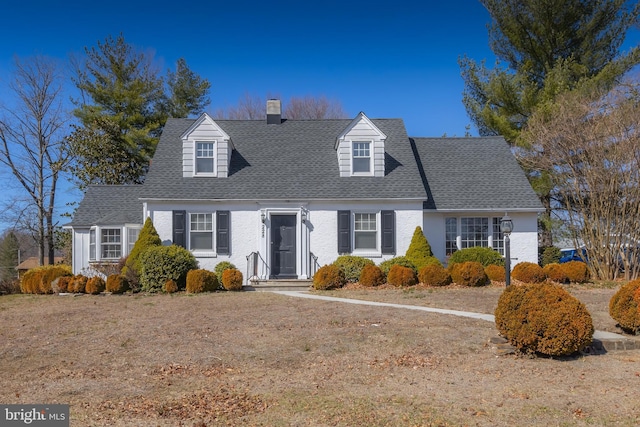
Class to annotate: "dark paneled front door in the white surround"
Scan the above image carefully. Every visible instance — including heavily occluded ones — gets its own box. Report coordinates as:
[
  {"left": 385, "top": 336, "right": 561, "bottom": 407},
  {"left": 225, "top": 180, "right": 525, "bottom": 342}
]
[{"left": 271, "top": 215, "right": 298, "bottom": 279}]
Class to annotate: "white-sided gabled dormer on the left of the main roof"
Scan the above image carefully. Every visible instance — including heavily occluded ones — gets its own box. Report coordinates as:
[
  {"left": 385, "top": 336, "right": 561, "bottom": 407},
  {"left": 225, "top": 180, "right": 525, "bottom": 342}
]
[{"left": 180, "top": 113, "right": 233, "bottom": 178}]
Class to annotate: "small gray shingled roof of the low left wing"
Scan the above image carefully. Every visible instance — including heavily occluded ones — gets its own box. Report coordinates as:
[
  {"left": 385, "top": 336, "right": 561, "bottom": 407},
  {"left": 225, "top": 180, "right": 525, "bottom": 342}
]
[{"left": 67, "top": 185, "right": 142, "bottom": 227}]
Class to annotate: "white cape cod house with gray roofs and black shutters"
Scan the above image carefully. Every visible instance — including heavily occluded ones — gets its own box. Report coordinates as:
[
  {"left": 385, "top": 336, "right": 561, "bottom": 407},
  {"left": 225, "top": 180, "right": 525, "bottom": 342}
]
[{"left": 68, "top": 100, "right": 542, "bottom": 279}]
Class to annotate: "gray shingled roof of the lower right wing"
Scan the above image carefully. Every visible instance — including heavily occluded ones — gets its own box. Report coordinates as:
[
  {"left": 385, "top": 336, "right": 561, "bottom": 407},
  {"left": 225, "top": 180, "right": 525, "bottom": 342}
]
[{"left": 412, "top": 137, "right": 542, "bottom": 211}]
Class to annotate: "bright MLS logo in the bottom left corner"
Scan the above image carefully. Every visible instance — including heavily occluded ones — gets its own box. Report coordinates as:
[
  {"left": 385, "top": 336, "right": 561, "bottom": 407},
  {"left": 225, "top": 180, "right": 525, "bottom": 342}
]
[{"left": 0, "top": 405, "right": 69, "bottom": 427}]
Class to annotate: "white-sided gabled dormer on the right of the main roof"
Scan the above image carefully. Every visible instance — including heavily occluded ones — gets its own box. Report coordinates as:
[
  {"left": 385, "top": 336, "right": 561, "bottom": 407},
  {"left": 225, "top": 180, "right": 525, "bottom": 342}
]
[{"left": 335, "top": 112, "right": 387, "bottom": 177}]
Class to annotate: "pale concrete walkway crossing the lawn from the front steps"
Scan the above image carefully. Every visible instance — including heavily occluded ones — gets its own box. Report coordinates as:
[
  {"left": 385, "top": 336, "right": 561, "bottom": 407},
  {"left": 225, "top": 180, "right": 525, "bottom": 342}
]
[{"left": 272, "top": 291, "right": 640, "bottom": 350}]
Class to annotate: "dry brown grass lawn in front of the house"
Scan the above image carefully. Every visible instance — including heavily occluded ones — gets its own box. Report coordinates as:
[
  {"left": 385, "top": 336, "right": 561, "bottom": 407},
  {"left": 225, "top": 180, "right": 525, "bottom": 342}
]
[{"left": 0, "top": 287, "right": 640, "bottom": 426}]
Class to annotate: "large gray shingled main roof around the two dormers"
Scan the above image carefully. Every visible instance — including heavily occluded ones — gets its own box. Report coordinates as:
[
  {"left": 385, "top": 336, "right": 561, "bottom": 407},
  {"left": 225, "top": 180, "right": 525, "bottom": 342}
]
[{"left": 143, "top": 119, "right": 425, "bottom": 200}]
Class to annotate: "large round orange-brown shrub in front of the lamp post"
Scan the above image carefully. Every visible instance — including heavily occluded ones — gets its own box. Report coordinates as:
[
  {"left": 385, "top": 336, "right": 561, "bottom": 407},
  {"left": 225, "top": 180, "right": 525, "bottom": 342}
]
[{"left": 495, "top": 282, "right": 593, "bottom": 356}]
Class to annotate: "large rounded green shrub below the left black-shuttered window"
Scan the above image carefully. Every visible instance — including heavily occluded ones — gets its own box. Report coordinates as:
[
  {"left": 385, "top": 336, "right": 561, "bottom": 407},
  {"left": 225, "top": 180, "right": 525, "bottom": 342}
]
[{"left": 140, "top": 245, "right": 198, "bottom": 292}]
